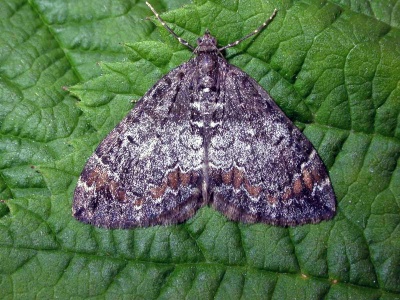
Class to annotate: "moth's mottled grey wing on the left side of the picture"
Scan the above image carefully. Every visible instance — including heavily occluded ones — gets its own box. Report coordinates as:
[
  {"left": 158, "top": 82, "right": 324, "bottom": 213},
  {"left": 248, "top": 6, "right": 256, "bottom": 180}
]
[{"left": 73, "top": 61, "right": 204, "bottom": 228}]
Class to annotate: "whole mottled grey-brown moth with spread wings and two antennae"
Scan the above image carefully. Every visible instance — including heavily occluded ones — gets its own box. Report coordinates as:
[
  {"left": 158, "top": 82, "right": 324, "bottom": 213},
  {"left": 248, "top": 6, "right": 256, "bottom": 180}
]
[{"left": 72, "top": 3, "right": 336, "bottom": 228}]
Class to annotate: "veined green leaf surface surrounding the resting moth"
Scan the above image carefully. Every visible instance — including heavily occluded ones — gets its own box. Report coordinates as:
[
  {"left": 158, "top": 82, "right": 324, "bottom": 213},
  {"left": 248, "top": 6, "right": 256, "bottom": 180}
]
[{"left": 0, "top": 0, "right": 400, "bottom": 299}]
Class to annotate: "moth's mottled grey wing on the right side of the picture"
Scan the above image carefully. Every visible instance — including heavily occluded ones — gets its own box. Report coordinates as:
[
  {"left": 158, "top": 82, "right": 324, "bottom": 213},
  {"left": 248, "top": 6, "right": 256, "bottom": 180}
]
[{"left": 208, "top": 59, "right": 336, "bottom": 226}]
